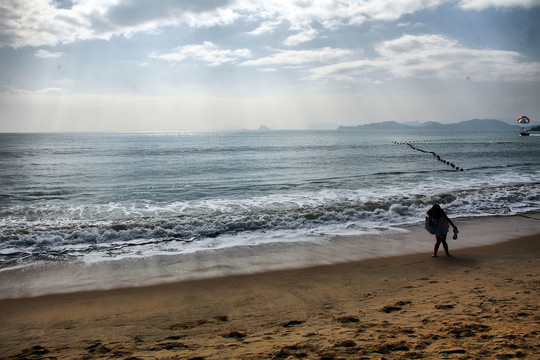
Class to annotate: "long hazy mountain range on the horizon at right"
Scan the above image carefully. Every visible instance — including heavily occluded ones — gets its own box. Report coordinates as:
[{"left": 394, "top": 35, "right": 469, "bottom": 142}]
[{"left": 338, "top": 119, "right": 518, "bottom": 131}]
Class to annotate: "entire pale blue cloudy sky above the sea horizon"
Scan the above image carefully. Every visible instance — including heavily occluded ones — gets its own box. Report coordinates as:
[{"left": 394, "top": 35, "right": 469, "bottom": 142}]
[{"left": 0, "top": 0, "right": 540, "bottom": 132}]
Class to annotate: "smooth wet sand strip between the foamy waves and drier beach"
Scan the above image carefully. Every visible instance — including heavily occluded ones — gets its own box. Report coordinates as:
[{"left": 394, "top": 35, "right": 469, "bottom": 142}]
[{"left": 0, "top": 211, "right": 540, "bottom": 299}]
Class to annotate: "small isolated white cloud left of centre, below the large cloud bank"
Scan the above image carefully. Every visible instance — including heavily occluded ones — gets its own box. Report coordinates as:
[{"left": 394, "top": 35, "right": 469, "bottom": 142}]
[{"left": 150, "top": 41, "right": 251, "bottom": 66}]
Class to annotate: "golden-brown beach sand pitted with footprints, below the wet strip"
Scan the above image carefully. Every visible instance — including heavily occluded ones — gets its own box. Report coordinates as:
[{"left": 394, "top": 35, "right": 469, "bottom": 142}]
[{"left": 0, "top": 234, "right": 540, "bottom": 359}]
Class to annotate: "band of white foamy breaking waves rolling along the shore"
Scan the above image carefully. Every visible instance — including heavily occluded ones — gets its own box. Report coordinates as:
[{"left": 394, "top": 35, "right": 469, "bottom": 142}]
[{"left": 0, "top": 172, "right": 540, "bottom": 263}]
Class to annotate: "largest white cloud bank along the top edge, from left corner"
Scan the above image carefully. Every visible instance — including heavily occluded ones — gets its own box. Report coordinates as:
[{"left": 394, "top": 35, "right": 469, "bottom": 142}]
[{"left": 0, "top": 0, "right": 448, "bottom": 48}]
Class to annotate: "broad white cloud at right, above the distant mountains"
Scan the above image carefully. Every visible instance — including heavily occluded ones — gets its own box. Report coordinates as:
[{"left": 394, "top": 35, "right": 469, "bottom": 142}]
[{"left": 311, "top": 35, "right": 540, "bottom": 81}]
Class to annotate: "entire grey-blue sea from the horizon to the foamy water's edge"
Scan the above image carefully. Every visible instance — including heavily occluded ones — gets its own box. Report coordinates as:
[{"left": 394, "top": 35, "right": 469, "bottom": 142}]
[{"left": 0, "top": 129, "right": 540, "bottom": 296}]
